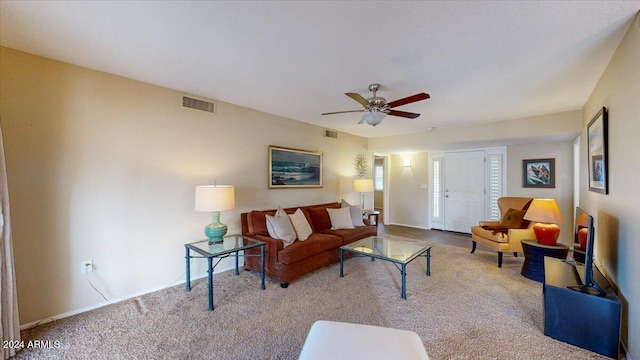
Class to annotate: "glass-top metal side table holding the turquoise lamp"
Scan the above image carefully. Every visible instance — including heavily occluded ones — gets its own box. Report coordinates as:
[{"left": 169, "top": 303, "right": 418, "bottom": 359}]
[{"left": 184, "top": 235, "right": 265, "bottom": 311}]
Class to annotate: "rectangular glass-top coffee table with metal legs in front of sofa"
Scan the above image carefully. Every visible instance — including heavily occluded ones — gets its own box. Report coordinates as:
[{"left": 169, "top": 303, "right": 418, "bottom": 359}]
[{"left": 340, "top": 236, "right": 431, "bottom": 299}]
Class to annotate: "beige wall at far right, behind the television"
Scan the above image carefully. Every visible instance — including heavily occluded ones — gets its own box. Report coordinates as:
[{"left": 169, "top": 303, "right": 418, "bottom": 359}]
[{"left": 580, "top": 12, "right": 640, "bottom": 359}]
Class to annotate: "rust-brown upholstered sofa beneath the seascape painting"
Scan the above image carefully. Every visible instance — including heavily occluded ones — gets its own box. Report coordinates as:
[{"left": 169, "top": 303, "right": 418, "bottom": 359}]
[{"left": 240, "top": 202, "right": 378, "bottom": 288}]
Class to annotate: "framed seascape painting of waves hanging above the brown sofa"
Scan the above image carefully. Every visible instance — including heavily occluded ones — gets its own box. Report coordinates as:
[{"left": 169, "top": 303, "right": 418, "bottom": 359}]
[{"left": 269, "top": 145, "right": 322, "bottom": 189}]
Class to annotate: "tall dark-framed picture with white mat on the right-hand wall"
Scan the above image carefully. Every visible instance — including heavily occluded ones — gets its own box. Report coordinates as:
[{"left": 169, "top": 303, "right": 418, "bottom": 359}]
[{"left": 587, "top": 107, "right": 609, "bottom": 194}]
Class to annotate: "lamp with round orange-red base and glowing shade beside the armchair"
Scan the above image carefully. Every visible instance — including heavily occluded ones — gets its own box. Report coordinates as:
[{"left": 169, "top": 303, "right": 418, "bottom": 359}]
[{"left": 524, "top": 199, "right": 564, "bottom": 245}]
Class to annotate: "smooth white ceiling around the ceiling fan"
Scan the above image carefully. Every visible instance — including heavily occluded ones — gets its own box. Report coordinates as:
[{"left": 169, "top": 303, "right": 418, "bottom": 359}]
[{"left": 0, "top": 0, "right": 640, "bottom": 137}]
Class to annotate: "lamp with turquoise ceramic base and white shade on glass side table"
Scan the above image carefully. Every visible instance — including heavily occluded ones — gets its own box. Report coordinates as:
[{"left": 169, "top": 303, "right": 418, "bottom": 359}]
[{"left": 195, "top": 185, "right": 235, "bottom": 243}]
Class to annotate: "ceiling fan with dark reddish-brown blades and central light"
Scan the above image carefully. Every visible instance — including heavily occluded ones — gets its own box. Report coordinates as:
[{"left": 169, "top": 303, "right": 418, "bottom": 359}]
[{"left": 322, "top": 84, "right": 430, "bottom": 126}]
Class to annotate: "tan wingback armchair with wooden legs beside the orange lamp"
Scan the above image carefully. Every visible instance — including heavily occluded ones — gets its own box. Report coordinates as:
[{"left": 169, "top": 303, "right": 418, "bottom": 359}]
[{"left": 471, "top": 197, "right": 536, "bottom": 267}]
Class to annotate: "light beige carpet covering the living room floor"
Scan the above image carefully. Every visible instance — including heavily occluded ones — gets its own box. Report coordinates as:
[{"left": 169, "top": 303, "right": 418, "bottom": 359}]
[{"left": 18, "top": 235, "right": 605, "bottom": 360}]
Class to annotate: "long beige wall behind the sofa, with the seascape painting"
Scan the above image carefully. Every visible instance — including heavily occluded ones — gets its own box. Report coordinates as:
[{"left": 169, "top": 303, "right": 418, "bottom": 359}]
[{"left": 0, "top": 48, "right": 373, "bottom": 324}]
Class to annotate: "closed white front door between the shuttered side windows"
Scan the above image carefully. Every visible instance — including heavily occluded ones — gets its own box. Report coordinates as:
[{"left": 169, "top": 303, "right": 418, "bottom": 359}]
[{"left": 444, "top": 151, "right": 486, "bottom": 233}]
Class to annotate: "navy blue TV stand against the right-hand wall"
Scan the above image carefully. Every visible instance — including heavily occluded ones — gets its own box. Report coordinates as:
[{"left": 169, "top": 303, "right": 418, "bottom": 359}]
[{"left": 544, "top": 257, "right": 621, "bottom": 359}]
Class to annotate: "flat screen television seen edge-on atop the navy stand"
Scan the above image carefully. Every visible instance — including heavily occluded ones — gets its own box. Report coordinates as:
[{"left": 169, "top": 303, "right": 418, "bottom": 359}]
[{"left": 569, "top": 207, "right": 605, "bottom": 296}]
